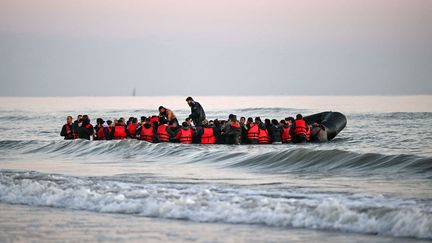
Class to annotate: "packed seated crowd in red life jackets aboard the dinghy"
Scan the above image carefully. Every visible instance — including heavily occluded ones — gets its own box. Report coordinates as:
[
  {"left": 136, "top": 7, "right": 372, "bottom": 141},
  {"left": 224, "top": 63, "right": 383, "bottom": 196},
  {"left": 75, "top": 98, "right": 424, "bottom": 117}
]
[{"left": 61, "top": 113, "right": 311, "bottom": 144}]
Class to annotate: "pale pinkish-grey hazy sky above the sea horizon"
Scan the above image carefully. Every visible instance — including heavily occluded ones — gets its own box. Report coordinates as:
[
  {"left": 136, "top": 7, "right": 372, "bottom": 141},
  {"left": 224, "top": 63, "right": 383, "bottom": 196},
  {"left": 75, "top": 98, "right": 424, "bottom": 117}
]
[{"left": 0, "top": 0, "right": 432, "bottom": 96}]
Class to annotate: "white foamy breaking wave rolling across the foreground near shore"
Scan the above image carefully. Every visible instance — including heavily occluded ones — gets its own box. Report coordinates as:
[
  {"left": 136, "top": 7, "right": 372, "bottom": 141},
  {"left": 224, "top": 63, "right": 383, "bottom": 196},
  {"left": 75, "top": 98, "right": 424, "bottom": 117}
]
[{"left": 0, "top": 172, "right": 432, "bottom": 239}]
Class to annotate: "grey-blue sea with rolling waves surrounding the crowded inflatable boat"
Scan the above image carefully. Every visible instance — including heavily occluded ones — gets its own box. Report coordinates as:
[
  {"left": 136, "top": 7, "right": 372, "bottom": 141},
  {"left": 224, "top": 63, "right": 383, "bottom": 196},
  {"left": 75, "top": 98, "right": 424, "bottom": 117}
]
[{"left": 0, "top": 96, "right": 432, "bottom": 242}]
